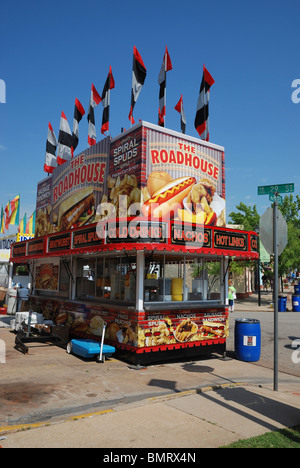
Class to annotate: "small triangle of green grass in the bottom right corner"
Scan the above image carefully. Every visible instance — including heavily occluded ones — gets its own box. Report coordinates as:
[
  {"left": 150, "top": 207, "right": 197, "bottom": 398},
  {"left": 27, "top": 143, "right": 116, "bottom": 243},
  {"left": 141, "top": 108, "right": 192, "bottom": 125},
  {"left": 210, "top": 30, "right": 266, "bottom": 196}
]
[{"left": 220, "top": 425, "right": 300, "bottom": 448}]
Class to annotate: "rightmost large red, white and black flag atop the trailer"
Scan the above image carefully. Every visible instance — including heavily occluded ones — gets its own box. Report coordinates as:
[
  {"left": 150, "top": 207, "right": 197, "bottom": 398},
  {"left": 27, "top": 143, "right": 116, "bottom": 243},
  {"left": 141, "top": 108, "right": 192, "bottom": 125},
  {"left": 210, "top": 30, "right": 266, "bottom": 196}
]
[{"left": 195, "top": 65, "right": 215, "bottom": 141}]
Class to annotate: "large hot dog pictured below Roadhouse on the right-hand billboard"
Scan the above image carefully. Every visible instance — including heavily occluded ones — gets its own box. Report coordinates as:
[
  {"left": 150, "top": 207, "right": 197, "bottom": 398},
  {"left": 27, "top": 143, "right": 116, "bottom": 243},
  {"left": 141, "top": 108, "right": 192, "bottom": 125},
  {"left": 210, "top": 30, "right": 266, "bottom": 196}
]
[{"left": 142, "top": 177, "right": 196, "bottom": 219}]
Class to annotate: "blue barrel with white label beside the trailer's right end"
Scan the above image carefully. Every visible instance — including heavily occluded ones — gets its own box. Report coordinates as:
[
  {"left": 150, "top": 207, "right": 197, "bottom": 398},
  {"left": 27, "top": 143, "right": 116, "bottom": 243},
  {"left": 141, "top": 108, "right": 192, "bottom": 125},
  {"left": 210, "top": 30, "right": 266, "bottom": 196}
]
[{"left": 234, "top": 318, "right": 261, "bottom": 362}]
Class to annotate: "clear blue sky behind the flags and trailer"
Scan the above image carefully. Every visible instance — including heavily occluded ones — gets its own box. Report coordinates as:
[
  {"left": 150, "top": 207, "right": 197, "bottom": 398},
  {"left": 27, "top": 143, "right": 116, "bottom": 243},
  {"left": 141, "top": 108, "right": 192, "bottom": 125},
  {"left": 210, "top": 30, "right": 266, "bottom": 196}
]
[{"left": 0, "top": 0, "right": 300, "bottom": 232}]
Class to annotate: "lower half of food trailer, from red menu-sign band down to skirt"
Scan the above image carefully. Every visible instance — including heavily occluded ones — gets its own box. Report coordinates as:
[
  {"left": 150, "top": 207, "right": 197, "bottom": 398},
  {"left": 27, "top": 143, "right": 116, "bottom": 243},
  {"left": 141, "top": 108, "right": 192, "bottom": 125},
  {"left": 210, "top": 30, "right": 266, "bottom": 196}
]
[{"left": 11, "top": 218, "right": 258, "bottom": 364}]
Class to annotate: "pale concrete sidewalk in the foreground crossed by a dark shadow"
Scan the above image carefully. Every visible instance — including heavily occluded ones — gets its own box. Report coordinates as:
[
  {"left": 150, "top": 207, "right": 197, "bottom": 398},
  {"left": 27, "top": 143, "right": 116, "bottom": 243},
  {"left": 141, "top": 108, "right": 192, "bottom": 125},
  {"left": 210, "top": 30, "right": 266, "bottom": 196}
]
[{"left": 0, "top": 374, "right": 300, "bottom": 449}]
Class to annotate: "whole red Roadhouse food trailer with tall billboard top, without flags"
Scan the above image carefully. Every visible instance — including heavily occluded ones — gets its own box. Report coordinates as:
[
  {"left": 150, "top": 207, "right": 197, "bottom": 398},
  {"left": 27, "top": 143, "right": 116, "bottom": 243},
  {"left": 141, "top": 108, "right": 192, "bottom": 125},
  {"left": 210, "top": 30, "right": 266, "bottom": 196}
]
[{"left": 11, "top": 122, "right": 258, "bottom": 364}]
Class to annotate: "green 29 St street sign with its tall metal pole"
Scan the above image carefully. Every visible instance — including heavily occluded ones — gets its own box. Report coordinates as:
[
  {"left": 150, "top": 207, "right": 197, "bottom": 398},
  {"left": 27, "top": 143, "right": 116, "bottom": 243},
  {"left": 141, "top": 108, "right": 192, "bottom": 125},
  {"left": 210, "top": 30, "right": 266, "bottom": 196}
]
[{"left": 257, "top": 184, "right": 295, "bottom": 391}]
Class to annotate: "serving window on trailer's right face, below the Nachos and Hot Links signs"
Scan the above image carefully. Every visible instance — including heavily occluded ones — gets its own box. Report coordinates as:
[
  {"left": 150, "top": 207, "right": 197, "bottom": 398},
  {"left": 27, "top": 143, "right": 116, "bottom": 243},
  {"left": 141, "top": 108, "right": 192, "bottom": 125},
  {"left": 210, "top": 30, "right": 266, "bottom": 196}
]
[{"left": 144, "top": 254, "right": 223, "bottom": 302}]
